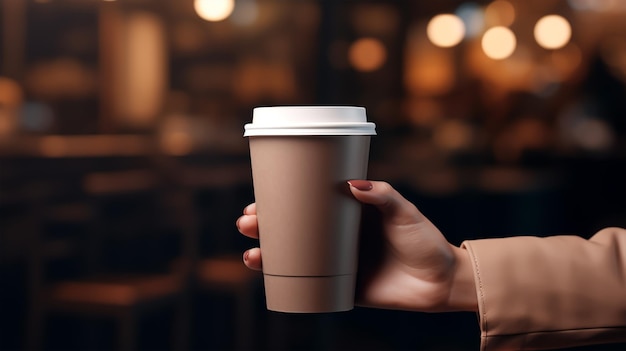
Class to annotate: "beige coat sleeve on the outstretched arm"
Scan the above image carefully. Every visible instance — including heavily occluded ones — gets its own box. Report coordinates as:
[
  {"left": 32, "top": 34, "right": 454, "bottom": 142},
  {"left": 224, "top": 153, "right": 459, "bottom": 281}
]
[{"left": 462, "top": 228, "right": 626, "bottom": 351}]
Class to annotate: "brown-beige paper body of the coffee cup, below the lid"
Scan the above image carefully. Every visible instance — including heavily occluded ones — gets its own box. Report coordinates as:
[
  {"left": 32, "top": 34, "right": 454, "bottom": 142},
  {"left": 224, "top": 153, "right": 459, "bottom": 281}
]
[{"left": 250, "top": 136, "right": 370, "bottom": 312}]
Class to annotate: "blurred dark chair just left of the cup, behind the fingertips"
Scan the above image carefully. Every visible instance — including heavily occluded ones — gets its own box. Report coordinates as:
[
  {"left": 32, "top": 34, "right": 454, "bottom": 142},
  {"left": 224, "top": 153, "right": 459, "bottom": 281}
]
[{"left": 177, "top": 164, "right": 261, "bottom": 350}]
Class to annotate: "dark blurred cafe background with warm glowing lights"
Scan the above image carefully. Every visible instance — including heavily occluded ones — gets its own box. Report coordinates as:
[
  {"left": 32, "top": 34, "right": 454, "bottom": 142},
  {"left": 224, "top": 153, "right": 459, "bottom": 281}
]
[{"left": 0, "top": 0, "right": 626, "bottom": 350}]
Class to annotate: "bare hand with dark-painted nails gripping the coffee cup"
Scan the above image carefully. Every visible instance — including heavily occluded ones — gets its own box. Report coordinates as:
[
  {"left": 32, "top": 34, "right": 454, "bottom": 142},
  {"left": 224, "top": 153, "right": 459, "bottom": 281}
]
[{"left": 237, "top": 180, "right": 478, "bottom": 312}]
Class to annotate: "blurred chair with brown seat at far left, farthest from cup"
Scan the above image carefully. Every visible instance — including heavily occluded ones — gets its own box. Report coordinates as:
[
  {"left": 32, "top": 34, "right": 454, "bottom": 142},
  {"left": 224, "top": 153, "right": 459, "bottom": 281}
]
[{"left": 28, "top": 170, "right": 194, "bottom": 350}]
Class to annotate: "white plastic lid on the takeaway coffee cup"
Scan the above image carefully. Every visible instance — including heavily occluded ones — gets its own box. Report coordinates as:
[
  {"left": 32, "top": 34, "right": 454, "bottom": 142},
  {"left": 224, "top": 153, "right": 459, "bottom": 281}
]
[{"left": 243, "top": 106, "right": 376, "bottom": 137}]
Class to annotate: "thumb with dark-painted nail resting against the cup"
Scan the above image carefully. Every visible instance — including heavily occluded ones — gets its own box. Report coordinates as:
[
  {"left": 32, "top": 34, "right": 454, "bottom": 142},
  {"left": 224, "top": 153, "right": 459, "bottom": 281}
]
[{"left": 348, "top": 180, "right": 426, "bottom": 224}]
